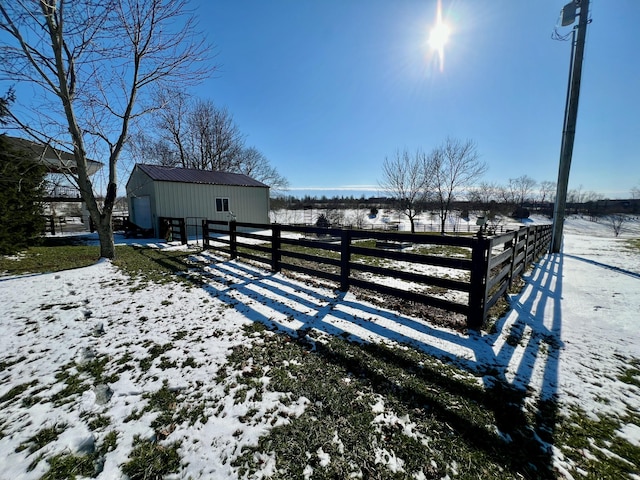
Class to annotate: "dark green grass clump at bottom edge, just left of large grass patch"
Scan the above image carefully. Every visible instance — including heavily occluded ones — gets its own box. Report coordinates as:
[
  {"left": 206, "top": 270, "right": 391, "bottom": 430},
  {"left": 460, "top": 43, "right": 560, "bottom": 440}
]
[{"left": 122, "top": 437, "right": 180, "bottom": 480}]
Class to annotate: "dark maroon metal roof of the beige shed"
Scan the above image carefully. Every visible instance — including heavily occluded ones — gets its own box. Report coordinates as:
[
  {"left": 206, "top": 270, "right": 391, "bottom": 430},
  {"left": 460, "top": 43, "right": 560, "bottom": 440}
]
[{"left": 136, "top": 163, "right": 269, "bottom": 188}]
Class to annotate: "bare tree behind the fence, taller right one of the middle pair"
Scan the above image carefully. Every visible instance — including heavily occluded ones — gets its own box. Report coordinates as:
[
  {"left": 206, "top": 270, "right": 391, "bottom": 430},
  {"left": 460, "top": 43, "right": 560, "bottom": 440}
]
[{"left": 426, "top": 138, "right": 487, "bottom": 235}]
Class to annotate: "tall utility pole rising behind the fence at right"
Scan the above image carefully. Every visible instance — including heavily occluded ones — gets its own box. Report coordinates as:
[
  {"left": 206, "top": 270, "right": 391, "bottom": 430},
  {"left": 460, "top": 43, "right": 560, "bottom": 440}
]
[{"left": 551, "top": 0, "right": 589, "bottom": 253}]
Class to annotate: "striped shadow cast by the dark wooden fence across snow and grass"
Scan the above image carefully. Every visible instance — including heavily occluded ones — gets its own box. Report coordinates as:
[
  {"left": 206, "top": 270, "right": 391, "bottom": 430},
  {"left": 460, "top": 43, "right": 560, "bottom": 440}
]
[{"left": 168, "top": 252, "right": 562, "bottom": 477}]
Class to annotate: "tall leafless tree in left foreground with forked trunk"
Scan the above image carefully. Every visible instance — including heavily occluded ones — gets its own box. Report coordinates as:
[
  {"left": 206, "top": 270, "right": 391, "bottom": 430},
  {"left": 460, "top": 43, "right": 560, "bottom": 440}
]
[{"left": 0, "top": 0, "right": 210, "bottom": 258}]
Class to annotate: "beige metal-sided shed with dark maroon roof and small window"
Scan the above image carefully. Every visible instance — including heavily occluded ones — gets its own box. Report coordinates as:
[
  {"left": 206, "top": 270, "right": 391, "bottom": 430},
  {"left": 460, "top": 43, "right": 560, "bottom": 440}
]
[{"left": 126, "top": 163, "right": 269, "bottom": 236}]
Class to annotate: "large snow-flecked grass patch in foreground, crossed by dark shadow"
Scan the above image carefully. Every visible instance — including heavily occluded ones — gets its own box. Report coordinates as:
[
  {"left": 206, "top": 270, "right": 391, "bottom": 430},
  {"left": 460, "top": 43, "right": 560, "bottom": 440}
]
[{"left": 227, "top": 326, "right": 553, "bottom": 479}]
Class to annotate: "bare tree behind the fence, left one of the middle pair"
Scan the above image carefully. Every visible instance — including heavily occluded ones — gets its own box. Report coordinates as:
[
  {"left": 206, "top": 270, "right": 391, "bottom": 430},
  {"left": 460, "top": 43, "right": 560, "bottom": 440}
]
[{"left": 379, "top": 150, "right": 431, "bottom": 233}]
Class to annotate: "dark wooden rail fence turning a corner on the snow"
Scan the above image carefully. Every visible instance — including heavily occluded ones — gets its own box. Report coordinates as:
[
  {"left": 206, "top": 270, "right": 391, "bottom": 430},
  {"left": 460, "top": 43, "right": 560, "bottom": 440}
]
[{"left": 202, "top": 220, "right": 551, "bottom": 330}]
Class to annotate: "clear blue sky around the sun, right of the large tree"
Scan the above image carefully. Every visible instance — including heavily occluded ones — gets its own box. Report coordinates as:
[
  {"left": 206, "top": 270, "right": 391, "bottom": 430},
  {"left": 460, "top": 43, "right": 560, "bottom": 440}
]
[{"left": 193, "top": 0, "right": 640, "bottom": 198}]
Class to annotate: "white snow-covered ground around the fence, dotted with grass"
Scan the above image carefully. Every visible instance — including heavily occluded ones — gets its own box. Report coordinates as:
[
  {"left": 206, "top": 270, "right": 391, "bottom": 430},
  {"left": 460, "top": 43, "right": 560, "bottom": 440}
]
[{"left": 0, "top": 218, "right": 640, "bottom": 479}]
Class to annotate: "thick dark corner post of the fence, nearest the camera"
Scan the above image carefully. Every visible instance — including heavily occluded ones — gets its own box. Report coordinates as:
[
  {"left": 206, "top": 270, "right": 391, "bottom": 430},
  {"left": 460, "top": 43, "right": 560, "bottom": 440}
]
[{"left": 467, "top": 236, "right": 491, "bottom": 330}]
